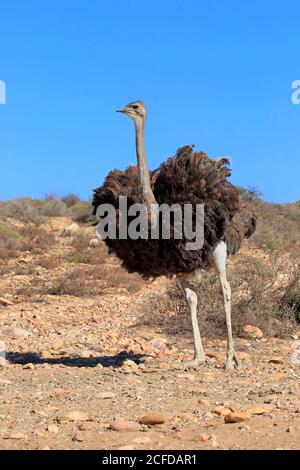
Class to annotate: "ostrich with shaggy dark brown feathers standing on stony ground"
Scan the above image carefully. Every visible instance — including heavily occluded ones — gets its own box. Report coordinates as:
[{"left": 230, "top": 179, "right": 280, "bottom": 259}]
[{"left": 93, "top": 101, "right": 256, "bottom": 369}]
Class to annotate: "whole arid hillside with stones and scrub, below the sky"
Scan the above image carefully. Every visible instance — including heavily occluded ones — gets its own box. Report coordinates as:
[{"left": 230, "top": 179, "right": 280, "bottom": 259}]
[{"left": 0, "top": 190, "right": 300, "bottom": 449}]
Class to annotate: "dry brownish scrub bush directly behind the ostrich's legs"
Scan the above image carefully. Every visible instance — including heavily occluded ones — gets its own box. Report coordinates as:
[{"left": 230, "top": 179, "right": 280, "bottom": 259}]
[{"left": 142, "top": 258, "right": 300, "bottom": 338}]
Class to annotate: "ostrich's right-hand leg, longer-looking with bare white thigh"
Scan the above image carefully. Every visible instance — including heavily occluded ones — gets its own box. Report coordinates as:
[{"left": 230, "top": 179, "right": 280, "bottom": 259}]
[{"left": 213, "top": 242, "right": 240, "bottom": 370}]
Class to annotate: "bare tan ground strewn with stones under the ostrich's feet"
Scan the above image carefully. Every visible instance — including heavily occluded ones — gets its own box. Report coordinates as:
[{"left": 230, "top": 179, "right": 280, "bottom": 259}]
[{"left": 0, "top": 221, "right": 300, "bottom": 449}]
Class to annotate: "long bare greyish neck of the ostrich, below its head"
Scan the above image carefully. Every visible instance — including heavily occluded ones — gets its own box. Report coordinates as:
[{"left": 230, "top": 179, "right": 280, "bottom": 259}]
[{"left": 135, "top": 122, "right": 156, "bottom": 210}]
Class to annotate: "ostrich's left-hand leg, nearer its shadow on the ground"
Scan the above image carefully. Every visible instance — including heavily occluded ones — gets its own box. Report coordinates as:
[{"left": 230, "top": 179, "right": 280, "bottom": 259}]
[{"left": 179, "top": 278, "right": 205, "bottom": 369}]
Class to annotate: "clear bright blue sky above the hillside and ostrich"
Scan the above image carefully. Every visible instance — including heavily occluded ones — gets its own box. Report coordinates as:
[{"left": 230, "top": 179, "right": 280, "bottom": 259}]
[{"left": 0, "top": 0, "right": 300, "bottom": 202}]
